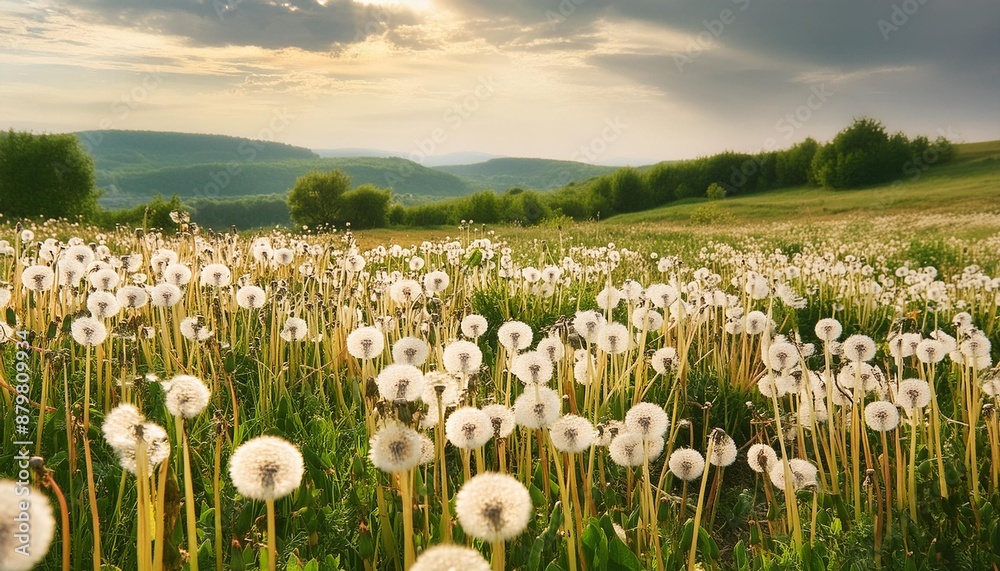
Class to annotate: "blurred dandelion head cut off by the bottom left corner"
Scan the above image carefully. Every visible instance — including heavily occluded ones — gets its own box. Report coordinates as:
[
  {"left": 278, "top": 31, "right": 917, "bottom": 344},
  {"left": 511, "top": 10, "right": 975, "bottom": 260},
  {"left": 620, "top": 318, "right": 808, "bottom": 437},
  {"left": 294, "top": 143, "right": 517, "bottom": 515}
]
[{"left": 0, "top": 479, "right": 56, "bottom": 571}]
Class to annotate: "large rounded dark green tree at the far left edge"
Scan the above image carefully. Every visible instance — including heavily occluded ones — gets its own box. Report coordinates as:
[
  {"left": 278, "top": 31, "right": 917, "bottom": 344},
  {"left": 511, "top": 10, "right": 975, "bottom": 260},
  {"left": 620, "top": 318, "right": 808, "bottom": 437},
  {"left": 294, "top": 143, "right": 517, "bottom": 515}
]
[{"left": 0, "top": 129, "right": 99, "bottom": 219}]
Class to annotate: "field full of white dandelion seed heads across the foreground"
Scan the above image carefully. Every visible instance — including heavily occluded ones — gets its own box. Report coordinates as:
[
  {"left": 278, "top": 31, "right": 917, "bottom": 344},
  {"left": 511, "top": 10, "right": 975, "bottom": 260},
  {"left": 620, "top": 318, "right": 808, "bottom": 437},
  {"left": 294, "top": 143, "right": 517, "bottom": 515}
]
[{"left": 0, "top": 216, "right": 1000, "bottom": 571}]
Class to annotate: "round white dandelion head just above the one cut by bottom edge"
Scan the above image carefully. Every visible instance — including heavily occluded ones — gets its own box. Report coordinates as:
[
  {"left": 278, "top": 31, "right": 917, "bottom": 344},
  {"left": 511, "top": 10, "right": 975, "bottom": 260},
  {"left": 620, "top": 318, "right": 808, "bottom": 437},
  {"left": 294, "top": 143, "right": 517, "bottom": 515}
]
[{"left": 455, "top": 473, "right": 532, "bottom": 542}]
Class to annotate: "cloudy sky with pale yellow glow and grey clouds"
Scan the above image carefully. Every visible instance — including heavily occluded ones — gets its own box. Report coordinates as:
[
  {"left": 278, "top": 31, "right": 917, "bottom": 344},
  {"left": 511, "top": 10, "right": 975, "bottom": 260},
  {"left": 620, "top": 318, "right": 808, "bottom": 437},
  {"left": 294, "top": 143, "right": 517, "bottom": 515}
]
[{"left": 0, "top": 0, "right": 1000, "bottom": 163}]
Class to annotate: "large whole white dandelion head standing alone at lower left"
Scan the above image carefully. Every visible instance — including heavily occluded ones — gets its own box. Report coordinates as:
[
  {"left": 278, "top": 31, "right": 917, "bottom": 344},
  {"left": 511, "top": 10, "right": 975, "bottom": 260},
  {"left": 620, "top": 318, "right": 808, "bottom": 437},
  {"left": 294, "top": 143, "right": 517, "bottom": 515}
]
[{"left": 229, "top": 436, "right": 304, "bottom": 500}]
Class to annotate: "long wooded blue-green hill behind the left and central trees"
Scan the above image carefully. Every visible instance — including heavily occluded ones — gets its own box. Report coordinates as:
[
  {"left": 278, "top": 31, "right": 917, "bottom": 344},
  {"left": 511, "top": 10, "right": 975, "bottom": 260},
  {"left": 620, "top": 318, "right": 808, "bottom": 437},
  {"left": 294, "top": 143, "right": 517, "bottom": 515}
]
[{"left": 76, "top": 131, "right": 476, "bottom": 208}]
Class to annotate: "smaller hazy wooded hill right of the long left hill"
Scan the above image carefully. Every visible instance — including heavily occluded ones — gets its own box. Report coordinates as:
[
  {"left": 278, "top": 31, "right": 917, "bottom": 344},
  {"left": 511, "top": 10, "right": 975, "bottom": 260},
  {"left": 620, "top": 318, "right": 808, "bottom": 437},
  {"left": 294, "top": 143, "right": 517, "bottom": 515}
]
[{"left": 434, "top": 158, "right": 617, "bottom": 191}]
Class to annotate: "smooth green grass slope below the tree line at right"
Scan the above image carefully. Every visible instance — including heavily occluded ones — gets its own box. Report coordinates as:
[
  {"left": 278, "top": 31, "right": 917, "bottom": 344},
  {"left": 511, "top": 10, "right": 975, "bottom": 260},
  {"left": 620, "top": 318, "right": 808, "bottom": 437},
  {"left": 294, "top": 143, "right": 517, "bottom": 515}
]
[{"left": 608, "top": 141, "right": 1000, "bottom": 225}]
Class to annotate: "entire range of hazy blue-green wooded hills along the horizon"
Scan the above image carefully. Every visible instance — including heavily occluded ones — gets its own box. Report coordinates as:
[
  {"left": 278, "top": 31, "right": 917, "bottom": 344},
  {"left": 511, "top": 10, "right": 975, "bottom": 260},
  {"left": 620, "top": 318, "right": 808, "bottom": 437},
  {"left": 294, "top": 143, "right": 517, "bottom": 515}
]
[{"left": 76, "top": 131, "right": 614, "bottom": 208}]
